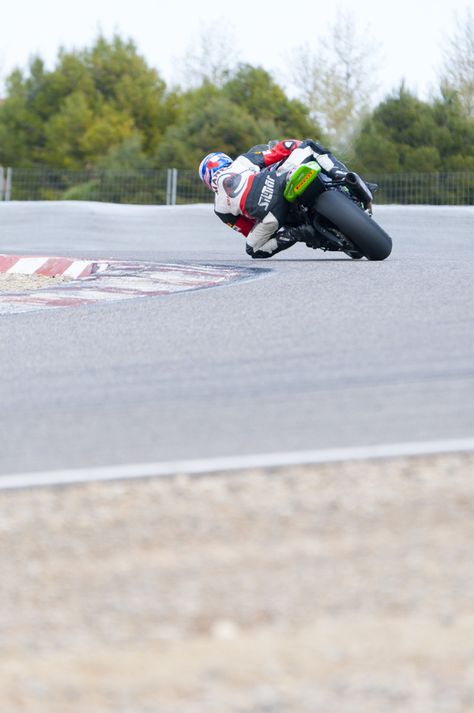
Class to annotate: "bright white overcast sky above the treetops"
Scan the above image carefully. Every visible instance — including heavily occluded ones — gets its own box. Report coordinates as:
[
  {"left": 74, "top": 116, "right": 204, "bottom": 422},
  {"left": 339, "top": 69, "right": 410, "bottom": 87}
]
[{"left": 0, "top": 0, "right": 474, "bottom": 98}]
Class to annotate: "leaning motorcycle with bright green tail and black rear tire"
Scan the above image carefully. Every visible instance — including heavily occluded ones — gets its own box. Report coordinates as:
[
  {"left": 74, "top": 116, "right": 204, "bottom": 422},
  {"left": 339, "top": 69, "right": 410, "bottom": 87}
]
[{"left": 284, "top": 161, "right": 392, "bottom": 260}]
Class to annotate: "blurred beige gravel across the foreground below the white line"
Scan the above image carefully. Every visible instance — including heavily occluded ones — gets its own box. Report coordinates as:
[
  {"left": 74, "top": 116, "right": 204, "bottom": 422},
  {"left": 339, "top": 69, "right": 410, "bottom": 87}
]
[{"left": 0, "top": 454, "right": 474, "bottom": 713}]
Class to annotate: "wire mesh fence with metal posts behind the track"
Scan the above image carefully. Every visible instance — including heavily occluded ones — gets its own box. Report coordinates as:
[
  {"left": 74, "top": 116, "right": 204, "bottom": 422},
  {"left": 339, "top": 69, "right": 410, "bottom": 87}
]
[{"left": 0, "top": 167, "right": 474, "bottom": 205}]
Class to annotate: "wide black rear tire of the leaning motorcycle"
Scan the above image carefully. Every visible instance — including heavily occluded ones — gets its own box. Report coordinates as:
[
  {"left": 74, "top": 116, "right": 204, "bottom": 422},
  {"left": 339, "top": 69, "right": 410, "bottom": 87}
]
[{"left": 315, "top": 190, "right": 392, "bottom": 260}]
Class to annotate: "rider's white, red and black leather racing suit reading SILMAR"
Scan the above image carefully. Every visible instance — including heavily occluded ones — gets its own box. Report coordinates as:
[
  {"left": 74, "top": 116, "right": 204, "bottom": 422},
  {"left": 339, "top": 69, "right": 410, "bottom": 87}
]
[{"left": 214, "top": 139, "right": 347, "bottom": 258}]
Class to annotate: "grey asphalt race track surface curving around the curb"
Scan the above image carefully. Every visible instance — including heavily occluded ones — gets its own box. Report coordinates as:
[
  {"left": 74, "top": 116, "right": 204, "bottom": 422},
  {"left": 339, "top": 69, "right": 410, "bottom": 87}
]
[{"left": 0, "top": 203, "right": 474, "bottom": 474}]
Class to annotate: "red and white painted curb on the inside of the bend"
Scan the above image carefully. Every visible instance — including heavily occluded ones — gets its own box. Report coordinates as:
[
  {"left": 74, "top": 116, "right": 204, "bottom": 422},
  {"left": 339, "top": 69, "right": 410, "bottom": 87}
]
[{"left": 0, "top": 255, "right": 261, "bottom": 314}]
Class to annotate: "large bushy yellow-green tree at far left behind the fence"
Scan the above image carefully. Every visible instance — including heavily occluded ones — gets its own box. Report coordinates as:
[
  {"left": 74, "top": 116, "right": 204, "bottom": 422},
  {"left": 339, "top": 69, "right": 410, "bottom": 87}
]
[{"left": 0, "top": 36, "right": 172, "bottom": 169}]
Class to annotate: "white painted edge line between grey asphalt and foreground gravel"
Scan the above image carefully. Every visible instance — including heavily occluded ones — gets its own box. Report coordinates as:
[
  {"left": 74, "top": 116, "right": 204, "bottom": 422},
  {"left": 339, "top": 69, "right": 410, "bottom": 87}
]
[{"left": 0, "top": 438, "right": 474, "bottom": 490}]
